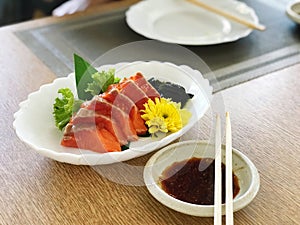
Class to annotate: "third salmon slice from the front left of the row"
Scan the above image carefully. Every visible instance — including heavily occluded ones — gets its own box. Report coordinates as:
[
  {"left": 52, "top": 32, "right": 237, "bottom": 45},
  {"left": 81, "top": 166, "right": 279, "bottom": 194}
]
[{"left": 86, "top": 96, "right": 138, "bottom": 141}]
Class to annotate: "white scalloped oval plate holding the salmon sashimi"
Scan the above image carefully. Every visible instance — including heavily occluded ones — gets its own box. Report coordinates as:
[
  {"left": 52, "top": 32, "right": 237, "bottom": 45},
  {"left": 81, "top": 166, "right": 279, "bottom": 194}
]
[{"left": 13, "top": 61, "right": 212, "bottom": 165}]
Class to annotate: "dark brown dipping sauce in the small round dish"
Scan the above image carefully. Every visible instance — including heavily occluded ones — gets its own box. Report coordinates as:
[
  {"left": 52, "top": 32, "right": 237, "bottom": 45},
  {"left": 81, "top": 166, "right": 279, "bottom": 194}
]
[{"left": 160, "top": 157, "right": 240, "bottom": 205}]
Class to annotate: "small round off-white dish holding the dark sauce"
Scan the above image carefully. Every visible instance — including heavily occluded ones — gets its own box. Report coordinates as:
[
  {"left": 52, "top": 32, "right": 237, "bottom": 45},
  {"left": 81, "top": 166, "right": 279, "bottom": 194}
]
[{"left": 144, "top": 140, "right": 260, "bottom": 217}]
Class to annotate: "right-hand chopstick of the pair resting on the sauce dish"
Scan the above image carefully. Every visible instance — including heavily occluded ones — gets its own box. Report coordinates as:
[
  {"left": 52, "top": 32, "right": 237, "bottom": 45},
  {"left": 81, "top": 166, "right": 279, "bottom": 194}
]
[{"left": 226, "top": 112, "right": 233, "bottom": 225}]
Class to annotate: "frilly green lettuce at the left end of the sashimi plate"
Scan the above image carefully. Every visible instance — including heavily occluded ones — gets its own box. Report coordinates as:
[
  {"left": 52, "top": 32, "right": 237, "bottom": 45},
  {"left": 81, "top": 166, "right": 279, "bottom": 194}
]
[{"left": 53, "top": 88, "right": 83, "bottom": 130}]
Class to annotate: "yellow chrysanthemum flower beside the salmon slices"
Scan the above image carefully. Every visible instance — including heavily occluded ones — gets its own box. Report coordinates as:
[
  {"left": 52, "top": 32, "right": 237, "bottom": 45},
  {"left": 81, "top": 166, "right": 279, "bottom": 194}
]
[{"left": 141, "top": 98, "right": 191, "bottom": 134}]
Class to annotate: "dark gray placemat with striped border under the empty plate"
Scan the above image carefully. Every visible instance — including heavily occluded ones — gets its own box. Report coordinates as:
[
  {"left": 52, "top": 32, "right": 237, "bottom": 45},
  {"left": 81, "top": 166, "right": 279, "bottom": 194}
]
[{"left": 16, "top": 0, "right": 300, "bottom": 91}]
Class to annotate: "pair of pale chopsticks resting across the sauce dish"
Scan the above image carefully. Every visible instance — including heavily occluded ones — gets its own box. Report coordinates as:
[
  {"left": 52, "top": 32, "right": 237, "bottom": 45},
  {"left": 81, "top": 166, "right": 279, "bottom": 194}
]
[{"left": 214, "top": 112, "right": 233, "bottom": 225}]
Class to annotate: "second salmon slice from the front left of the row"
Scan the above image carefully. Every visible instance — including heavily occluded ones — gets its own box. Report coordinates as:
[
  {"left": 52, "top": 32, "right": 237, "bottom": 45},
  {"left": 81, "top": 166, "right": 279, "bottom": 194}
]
[{"left": 72, "top": 108, "right": 128, "bottom": 145}]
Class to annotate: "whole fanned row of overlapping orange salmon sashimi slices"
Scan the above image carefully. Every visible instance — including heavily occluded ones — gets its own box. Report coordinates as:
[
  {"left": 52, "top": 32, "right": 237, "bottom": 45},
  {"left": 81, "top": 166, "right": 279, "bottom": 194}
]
[{"left": 61, "top": 73, "right": 160, "bottom": 153}]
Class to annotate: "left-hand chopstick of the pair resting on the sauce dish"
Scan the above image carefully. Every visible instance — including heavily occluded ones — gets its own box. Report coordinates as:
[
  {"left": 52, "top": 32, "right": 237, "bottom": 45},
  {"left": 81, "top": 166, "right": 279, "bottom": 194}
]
[{"left": 214, "top": 115, "right": 222, "bottom": 225}]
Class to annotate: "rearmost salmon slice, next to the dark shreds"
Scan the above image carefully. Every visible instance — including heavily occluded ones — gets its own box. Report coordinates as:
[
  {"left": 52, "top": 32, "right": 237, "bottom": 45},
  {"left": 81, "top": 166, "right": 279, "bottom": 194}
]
[{"left": 129, "top": 72, "right": 160, "bottom": 100}]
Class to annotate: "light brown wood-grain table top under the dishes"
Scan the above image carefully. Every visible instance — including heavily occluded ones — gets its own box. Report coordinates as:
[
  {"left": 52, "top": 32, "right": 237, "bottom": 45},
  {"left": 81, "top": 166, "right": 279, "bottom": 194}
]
[{"left": 0, "top": 1, "right": 300, "bottom": 225}]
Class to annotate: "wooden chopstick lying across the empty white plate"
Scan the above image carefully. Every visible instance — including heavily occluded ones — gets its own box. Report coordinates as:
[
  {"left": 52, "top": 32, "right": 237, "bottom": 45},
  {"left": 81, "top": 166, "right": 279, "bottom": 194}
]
[{"left": 186, "top": 0, "right": 266, "bottom": 31}]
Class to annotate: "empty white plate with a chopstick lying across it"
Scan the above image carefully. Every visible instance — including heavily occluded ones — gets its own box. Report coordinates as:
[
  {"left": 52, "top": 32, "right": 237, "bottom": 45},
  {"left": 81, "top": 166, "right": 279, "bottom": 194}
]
[{"left": 126, "top": 0, "right": 258, "bottom": 45}]
